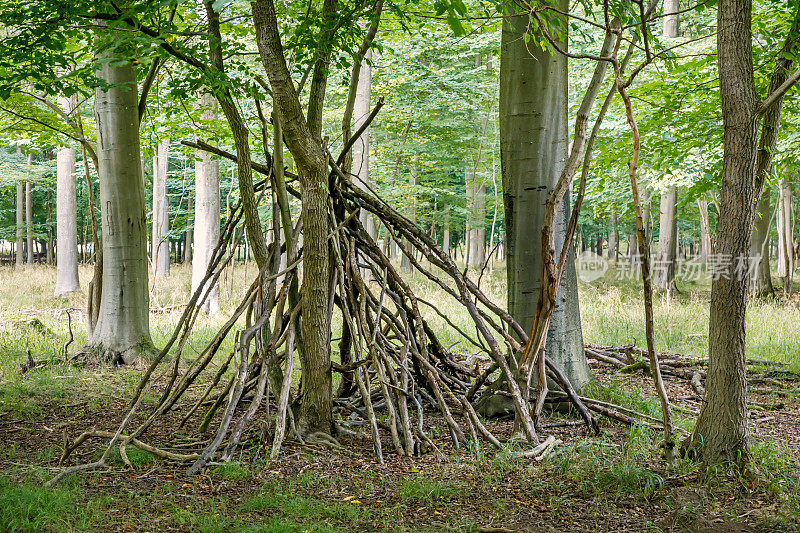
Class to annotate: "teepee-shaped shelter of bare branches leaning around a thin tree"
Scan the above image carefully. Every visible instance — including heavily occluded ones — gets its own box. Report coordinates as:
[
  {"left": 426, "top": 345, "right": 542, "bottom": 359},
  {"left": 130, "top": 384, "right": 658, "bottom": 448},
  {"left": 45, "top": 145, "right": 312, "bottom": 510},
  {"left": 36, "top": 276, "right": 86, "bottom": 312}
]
[{"left": 52, "top": 132, "right": 597, "bottom": 482}]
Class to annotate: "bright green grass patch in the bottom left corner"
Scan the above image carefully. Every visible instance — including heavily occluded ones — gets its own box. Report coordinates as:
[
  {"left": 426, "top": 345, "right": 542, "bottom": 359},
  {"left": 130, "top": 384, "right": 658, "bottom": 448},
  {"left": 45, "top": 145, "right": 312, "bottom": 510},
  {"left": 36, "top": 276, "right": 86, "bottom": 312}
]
[{"left": 0, "top": 478, "right": 100, "bottom": 532}]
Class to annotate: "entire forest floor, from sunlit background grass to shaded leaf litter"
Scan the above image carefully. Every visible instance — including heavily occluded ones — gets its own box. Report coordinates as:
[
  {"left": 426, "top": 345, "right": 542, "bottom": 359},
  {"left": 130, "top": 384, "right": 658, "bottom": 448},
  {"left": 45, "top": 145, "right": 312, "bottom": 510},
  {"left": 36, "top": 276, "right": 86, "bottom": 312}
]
[{"left": 0, "top": 267, "right": 800, "bottom": 532}]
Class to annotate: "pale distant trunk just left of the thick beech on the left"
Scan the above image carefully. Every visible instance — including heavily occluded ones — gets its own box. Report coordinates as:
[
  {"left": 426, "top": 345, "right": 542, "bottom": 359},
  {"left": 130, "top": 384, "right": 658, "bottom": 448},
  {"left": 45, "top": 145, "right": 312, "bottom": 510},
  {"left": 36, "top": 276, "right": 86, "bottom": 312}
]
[{"left": 54, "top": 96, "right": 81, "bottom": 296}]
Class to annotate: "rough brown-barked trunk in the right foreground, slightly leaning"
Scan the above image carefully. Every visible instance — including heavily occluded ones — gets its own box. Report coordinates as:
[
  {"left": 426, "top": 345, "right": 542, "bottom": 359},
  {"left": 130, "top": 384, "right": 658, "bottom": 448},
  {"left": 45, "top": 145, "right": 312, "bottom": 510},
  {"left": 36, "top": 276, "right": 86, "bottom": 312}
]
[{"left": 690, "top": 0, "right": 760, "bottom": 465}]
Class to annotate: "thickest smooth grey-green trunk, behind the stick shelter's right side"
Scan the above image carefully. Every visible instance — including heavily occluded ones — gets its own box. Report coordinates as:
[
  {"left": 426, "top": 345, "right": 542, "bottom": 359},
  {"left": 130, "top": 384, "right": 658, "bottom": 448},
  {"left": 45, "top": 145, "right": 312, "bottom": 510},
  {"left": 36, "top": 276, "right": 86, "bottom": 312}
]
[{"left": 500, "top": 0, "right": 590, "bottom": 388}]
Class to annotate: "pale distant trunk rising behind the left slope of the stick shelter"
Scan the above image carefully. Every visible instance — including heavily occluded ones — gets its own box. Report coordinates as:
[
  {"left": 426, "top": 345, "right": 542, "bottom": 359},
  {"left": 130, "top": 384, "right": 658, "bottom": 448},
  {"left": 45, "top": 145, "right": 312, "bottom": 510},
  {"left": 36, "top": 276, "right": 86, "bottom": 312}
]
[{"left": 192, "top": 95, "right": 220, "bottom": 314}]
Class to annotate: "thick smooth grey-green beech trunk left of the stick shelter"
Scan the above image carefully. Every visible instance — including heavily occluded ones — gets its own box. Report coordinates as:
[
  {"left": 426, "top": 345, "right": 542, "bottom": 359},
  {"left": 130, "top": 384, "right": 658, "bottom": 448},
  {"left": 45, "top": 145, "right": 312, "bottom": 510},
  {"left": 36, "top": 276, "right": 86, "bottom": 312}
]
[{"left": 86, "top": 35, "right": 154, "bottom": 364}]
